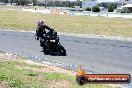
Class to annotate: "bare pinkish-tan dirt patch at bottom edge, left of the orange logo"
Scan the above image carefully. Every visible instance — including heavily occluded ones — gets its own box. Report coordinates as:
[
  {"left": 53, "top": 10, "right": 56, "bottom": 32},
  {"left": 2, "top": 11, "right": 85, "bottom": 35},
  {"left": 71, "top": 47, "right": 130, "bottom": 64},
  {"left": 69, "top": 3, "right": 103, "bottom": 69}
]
[{"left": 49, "top": 80, "right": 71, "bottom": 88}]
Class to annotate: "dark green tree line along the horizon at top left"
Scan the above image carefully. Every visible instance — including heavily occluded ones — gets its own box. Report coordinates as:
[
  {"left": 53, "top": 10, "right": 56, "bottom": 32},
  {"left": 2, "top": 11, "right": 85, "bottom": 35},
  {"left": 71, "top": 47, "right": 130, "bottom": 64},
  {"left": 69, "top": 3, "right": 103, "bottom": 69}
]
[{"left": 0, "top": 0, "right": 82, "bottom": 7}]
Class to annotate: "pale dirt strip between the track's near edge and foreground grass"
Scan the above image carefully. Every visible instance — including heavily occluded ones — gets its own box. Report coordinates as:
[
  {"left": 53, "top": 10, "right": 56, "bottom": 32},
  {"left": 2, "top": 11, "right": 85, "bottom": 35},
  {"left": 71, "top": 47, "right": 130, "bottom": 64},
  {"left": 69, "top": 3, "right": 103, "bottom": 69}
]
[{"left": 0, "top": 53, "right": 76, "bottom": 75}]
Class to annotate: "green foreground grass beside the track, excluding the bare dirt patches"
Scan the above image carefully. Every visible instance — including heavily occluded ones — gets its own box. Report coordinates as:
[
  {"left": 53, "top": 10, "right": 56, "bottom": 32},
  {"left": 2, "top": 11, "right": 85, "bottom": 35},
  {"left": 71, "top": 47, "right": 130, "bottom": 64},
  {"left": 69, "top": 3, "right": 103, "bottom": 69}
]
[{"left": 0, "top": 57, "right": 110, "bottom": 88}]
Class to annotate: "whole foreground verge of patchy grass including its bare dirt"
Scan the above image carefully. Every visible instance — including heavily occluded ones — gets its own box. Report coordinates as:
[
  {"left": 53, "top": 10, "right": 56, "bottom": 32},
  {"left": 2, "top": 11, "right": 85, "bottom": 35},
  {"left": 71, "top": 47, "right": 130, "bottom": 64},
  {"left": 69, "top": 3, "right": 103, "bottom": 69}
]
[{"left": 0, "top": 54, "right": 109, "bottom": 88}]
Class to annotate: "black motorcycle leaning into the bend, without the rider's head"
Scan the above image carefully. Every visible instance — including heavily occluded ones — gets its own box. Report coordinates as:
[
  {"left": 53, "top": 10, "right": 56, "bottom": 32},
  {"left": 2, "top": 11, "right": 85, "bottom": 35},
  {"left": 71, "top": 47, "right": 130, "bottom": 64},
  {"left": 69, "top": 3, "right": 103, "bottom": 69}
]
[{"left": 37, "top": 30, "right": 66, "bottom": 56}]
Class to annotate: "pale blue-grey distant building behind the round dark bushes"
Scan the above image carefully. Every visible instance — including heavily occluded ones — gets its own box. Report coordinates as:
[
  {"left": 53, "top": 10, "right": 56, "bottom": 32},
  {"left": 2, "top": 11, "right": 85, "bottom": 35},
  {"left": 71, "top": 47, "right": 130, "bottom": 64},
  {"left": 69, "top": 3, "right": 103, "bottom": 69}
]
[{"left": 82, "top": 0, "right": 97, "bottom": 8}]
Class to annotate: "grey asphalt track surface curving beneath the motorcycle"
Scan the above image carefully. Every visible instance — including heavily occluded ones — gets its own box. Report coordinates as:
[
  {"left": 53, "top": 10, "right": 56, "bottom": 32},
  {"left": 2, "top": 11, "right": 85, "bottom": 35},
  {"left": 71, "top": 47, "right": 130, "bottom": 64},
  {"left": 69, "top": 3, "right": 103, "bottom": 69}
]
[{"left": 0, "top": 30, "right": 132, "bottom": 75}]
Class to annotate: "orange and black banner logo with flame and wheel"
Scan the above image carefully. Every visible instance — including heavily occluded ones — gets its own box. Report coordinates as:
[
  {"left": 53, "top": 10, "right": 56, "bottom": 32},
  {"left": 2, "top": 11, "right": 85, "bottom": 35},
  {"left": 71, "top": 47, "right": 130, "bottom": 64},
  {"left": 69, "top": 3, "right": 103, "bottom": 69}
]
[{"left": 76, "top": 66, "right": 131, "bottom": 85}]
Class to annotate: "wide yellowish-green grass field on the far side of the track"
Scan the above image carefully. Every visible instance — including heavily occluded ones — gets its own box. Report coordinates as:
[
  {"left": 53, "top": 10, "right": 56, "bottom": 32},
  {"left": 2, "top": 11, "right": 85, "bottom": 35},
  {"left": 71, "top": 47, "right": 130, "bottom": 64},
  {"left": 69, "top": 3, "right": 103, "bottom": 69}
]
[{"left": 0, "top": 5, "right": 132, "bottom": 37}]
